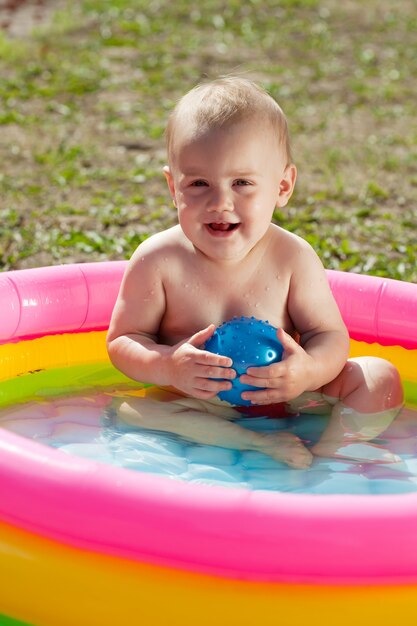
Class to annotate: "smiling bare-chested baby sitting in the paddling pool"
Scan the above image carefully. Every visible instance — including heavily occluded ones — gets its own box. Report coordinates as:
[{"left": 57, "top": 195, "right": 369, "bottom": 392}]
[{"left": 108, "top": 77, "right": 403, "bottom": 468}]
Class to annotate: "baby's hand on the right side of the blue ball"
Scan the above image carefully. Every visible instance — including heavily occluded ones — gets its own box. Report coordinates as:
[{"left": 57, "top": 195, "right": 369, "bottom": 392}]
[{"left": 240, "top": 328, "right": 314, "bottom": 404}]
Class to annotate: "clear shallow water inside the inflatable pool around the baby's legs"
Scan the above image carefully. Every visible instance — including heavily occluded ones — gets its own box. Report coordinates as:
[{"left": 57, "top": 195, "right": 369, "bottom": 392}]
[{"left": 0, "top": 392, "right": 417, "bottom": 495}]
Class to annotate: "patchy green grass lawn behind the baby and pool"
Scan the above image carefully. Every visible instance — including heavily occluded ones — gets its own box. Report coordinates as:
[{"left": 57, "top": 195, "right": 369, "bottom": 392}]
[{"left": 0, "top": 0, "right": 417, "bottom": 281}]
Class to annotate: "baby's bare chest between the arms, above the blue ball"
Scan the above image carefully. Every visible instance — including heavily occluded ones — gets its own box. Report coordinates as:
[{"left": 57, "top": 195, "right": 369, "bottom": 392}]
[{"left": 150, "top": 226, "right": 297, "bottom": 345}]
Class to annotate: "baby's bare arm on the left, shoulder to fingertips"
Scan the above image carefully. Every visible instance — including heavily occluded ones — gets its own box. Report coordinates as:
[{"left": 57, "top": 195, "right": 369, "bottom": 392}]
[{"left": 107, "top": 240, "right": 235, "bottom": 399}]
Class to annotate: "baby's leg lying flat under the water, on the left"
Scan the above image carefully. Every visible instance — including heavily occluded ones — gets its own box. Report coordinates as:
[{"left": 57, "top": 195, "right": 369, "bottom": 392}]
[{"left": 112, "top": 394, "right": 312, "bottom": 468}]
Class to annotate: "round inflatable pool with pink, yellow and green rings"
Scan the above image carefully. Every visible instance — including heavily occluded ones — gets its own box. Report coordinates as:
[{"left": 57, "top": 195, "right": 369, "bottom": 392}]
[{"left": 0, "top": 262, "right": 417, "bottom": 626}]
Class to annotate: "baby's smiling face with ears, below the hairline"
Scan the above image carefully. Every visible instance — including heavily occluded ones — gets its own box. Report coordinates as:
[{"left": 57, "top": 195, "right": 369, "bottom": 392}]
[{"left": 166, "top": 120, "right": 292, "bottom": 261}]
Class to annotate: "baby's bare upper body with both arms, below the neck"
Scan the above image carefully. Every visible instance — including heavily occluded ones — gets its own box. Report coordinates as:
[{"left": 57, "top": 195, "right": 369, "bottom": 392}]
[{"left": 107, "top": 216, "right": 348, "bottom": 420}]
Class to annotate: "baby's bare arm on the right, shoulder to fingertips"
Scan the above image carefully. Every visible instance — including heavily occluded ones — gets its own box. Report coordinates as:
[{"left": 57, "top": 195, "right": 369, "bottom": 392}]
[{"left": 241, "top": 236, "right": 349, "bottom": 404}]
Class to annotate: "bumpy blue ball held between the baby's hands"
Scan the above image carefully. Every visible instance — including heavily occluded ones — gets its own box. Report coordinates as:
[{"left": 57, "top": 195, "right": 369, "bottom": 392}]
[{"left": 205, "top": 317, "right": 284, "bottom": 406}]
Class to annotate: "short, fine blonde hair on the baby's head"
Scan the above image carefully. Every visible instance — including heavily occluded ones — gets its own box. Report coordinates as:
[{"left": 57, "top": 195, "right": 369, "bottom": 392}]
[{"left": 166, "top": 76, "right": 292, "bottom": 165}]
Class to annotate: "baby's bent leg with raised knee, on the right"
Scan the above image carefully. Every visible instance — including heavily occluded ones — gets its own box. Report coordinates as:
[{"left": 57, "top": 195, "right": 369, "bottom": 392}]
[{"left": 311, "top": 357, "right": 403, "bottom": 462}]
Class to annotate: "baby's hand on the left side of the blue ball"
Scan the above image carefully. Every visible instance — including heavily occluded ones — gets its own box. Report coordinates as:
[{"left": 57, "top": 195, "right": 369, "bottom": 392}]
[{"left": 169, "top": 324, "right": 236, "bottom": 400}]
